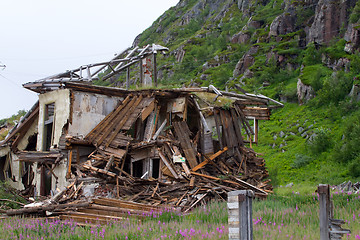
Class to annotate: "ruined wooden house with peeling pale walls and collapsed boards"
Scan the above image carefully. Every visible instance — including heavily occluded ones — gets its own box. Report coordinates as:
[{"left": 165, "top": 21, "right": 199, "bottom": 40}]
[{"left": 0, "top": 44, "right": 281, "bottom": 214}]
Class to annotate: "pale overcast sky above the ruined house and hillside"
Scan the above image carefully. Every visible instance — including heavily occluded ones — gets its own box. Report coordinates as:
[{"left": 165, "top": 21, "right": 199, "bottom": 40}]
[{"left": 0, "top": 0, "right": 179, "bottom": 119}]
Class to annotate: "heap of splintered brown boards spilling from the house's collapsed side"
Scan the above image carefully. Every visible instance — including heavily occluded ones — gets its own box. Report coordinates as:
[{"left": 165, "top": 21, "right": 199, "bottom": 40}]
[{"left": 76, "top": 95, "right": 272, "bottom": 211}]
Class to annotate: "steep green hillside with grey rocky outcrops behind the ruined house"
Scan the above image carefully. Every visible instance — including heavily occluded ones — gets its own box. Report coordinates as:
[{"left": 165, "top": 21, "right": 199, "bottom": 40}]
[{"left": 96, "top": 0, "right": 360, "bottom": 186}]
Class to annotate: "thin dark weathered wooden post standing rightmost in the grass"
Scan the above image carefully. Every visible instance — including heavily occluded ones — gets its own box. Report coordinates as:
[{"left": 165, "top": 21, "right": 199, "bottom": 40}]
[{"left": 318, "top": 184, "right": 330, "bottom": 240}]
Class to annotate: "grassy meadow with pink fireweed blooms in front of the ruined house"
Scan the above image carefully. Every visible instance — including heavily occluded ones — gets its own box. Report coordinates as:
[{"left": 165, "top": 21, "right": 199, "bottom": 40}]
[{"left": 0, "top": 191, "right": 360, "bottom": 240}]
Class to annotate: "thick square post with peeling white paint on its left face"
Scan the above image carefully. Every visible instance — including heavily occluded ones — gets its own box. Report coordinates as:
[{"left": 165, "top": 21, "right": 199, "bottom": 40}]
[{"left": 228, "top": 190, "right": 254, "bottom": 240}]
